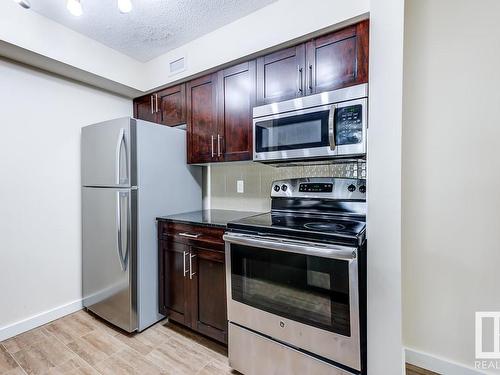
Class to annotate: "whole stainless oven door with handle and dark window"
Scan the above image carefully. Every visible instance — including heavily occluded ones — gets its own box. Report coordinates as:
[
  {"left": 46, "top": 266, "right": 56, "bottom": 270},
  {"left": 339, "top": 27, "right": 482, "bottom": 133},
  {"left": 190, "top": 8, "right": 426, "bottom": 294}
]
[{"left": 224, "top": 233, "right": 361, "bottom": 370}]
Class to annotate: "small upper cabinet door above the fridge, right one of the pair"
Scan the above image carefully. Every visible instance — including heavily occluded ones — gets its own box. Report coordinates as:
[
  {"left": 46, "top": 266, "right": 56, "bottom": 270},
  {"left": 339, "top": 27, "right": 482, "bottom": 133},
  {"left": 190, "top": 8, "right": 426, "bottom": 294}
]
[{"left": 157, "top": 83, "right": 186, "bottom": 126}]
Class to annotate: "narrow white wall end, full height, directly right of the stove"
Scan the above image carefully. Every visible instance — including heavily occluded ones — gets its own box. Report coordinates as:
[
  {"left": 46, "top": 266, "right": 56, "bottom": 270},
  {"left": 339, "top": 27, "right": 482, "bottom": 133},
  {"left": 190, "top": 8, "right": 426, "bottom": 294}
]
[{"left": 366, "top": 0, "right": 404, "bottom": 375}]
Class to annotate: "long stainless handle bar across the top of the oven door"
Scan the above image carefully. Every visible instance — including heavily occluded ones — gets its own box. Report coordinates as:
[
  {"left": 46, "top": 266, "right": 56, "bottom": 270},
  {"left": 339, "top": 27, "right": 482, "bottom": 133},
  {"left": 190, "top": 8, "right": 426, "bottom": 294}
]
[{"left": 223, "top": 233, "right": 358, "bottom": 260}]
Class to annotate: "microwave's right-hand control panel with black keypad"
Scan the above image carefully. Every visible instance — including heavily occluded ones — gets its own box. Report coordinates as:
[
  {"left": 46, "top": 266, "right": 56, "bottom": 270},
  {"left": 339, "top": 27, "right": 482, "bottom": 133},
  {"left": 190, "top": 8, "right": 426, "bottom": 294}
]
[{"left": 330, "top": 98, "right": 368, "bottom": 156}]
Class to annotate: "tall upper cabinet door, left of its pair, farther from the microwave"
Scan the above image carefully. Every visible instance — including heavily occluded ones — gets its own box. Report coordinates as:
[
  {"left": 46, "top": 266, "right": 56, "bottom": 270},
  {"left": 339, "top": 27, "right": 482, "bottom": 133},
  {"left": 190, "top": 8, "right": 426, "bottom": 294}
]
[{"left": 186, "top": 73, "right": 218, "bottom": 163}]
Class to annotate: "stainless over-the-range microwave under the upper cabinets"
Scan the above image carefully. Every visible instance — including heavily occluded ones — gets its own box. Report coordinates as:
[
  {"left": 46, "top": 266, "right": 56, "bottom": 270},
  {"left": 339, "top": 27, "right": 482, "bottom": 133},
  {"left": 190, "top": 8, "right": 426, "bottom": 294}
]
[{"left": 253, "top": 98, "right": 367, "bottom": 162}]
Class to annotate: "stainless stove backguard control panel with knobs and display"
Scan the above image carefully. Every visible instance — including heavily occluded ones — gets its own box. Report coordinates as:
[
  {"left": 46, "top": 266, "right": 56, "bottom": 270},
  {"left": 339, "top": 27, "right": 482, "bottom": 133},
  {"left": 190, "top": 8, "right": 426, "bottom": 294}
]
[{"left": 271, "top": 177, "right": 366, "bottom": 201}]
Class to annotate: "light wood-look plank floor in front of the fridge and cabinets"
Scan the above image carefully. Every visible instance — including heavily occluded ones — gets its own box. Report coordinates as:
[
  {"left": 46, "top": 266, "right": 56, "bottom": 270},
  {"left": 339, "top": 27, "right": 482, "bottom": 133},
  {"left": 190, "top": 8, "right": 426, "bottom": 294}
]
[{"left": 0, "top": 311, "right": 234, "bottom": 375}]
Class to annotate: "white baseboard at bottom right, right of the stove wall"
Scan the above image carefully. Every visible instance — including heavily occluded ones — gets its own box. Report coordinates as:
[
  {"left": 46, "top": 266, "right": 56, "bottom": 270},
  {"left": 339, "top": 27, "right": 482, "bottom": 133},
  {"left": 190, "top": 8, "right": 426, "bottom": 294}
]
[{"left": 405, "top": 348, "right": 485, "bottom": 375}]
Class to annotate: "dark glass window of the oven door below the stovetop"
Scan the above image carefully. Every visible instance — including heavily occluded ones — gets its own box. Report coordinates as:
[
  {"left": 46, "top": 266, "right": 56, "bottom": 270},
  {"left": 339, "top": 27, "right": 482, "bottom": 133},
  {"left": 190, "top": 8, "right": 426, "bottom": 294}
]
[{"left": 231, "top": 244, "right": 351, "bottom": 336}]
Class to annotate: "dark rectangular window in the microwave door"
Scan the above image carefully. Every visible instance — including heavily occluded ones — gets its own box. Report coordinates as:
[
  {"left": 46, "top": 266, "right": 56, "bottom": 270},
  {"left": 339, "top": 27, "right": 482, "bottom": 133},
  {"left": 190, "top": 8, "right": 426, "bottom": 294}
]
[{"left": 255, "top": 111, "right": 329, "bottom": 152}]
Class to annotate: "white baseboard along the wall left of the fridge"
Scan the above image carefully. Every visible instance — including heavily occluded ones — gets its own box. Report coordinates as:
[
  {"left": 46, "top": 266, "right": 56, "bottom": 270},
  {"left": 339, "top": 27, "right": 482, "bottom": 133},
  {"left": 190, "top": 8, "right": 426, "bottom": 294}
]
[{"left": 0, "top": 299, "right": 83, "bottom": 341}]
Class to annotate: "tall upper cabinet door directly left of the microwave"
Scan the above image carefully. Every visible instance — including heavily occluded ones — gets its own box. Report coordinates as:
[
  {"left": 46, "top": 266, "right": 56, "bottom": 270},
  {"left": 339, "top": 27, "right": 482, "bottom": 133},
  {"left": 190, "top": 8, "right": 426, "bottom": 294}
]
[{"left": 217, "top": 61, "right": 256, "bottom": 161}]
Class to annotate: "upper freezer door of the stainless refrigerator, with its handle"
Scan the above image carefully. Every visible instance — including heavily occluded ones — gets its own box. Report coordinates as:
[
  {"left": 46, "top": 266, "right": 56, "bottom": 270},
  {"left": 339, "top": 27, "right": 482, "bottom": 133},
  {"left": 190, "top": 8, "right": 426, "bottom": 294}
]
[{"left": 82, "top": 117, "right": 136, "bottom": 187}]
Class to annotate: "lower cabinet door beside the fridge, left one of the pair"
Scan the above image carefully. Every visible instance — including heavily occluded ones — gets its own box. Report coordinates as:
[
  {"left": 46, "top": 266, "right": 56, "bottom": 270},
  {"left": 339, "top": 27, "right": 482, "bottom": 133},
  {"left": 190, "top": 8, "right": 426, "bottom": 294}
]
[{"left": 159, "top": 240, "right": 192, "bottom": 325}]
